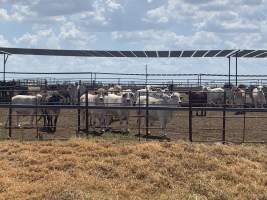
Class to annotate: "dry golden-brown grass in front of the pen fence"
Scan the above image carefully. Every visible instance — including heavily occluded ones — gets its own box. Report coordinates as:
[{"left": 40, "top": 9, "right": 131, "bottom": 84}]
[{"left": 0, "top": 139, "right": 267, "bottom": 200}]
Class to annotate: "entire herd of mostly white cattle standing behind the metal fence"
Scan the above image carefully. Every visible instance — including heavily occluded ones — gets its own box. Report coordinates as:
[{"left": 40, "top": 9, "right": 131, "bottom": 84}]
[{"left": 2, "top": 84, "right": 266, "bottom": 136}]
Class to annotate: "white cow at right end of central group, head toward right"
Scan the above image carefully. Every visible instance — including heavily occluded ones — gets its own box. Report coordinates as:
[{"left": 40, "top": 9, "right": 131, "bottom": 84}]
[{"left": 136, "top": 92, "right": 181, "bottom": 136}]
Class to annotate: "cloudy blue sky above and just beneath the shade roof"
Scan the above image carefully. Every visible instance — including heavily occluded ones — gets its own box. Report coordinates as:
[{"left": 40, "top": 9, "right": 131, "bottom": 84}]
[{"left": 0, "top": 0, "right": 267, "bottom": 79}]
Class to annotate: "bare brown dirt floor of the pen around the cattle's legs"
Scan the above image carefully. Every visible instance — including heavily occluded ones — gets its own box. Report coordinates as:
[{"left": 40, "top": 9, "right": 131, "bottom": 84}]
[{"left": 0, "top": 109, "right": 267, "bottom": 143}]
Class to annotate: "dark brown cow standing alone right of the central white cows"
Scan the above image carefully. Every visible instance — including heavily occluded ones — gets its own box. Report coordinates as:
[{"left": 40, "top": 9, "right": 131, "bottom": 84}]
[{"left": 189, "top": 92, "right": 207, "bottom": 116}]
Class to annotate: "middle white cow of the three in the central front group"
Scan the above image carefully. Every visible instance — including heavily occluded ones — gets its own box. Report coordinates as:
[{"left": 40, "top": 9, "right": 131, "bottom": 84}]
[{"left": 104, "top": 90, "right": 135, "bottom": 133}]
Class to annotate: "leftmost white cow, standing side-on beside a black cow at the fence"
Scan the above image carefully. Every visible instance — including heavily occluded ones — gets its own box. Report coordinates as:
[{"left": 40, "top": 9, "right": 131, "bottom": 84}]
[{"left": 5, "top": 94, "right": 42, "bottom": 127}]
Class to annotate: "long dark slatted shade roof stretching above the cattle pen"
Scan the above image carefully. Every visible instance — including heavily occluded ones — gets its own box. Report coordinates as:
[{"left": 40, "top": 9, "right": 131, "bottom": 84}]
[{"left": 0, "top": 47, "right": 267, "bottom": 58}]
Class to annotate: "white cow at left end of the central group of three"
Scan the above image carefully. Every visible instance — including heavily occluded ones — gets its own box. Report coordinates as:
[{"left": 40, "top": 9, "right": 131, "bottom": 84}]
[{"left": 80, "top": 88, "right": 107, "bottom": 132}]
